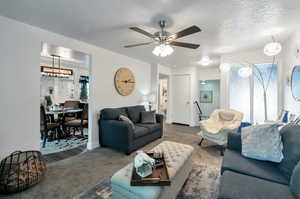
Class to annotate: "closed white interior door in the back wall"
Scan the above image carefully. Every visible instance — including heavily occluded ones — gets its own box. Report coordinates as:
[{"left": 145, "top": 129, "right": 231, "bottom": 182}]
[{"left": 172, "top": 75, "right": 191, "bottom": 125}]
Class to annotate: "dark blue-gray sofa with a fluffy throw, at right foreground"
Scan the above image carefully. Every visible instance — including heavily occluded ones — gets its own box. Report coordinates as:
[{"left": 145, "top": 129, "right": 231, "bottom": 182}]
[{"left": 218, "top": 125, "right": 300, "bottom": 199}]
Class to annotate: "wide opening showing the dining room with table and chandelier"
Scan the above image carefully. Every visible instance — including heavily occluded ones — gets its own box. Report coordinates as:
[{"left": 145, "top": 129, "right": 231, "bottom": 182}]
[{"left": 39, "top": 42, "right": 90, "bottom": 155}]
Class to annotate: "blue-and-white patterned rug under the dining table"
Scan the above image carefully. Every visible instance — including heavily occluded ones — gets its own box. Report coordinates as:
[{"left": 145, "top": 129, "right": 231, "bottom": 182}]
[{"left": 41, "top": 137, "right": 88, "bottom": 155}]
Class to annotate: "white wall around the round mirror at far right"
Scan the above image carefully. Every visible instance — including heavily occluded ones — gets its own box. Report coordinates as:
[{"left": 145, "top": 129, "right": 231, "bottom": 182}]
[{"left": 281, "top": 29, "right": 300, "bottom": 115}]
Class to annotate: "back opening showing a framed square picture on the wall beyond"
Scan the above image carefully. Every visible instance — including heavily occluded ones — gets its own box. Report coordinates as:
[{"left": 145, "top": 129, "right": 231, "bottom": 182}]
[{"left": 199, "top": 80, "right": 220, "bottom": 119}]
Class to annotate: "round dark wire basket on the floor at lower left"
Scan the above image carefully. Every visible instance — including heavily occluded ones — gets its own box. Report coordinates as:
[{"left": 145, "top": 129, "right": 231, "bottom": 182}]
[{"left": 0, "top": 151, "right": 46, "bottom": 193}]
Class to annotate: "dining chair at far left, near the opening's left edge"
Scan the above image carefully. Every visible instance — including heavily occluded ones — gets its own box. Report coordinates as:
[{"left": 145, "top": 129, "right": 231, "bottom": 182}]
[{"left": 40, "top": 105, "right": 60, "bottom": 148}]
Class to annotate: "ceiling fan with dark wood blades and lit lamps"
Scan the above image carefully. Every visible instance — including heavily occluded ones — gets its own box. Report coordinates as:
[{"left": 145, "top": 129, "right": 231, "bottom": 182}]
[{"left": 124, "top": 20, "right": 201, "bottom": 53}]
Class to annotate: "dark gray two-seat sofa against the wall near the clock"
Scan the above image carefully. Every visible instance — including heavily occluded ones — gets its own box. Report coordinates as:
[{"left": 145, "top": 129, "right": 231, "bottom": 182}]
[{"left": 98, "top": 106, "right": 163, "bottom": 154}]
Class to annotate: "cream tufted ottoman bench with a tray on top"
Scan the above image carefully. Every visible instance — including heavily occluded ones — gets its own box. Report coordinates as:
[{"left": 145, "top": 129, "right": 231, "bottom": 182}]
[{"left": 111, "top": 141, "right": 194, "bottom": 199}]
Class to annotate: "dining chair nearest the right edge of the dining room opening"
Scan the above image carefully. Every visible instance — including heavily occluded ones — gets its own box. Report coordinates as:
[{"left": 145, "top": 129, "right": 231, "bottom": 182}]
[{"left": 64, "top": 104, "right": 88, "bottom": 137}]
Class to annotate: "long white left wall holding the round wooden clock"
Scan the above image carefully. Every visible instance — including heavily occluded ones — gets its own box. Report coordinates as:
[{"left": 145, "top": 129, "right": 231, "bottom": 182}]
[{"left": 0, "top": 17, "right": 151, "bottom": 158}]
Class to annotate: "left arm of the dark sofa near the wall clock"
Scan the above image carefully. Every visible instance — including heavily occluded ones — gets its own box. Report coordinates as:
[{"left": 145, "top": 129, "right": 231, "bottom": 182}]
[{"left": 100, "top": 120, "right": 133, "bottom": 149}]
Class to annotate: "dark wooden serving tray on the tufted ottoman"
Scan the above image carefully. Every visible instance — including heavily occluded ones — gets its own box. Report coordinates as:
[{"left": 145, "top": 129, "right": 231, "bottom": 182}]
[{"left": 130, "top": 153, "right": 171, "bottom": 186}]
